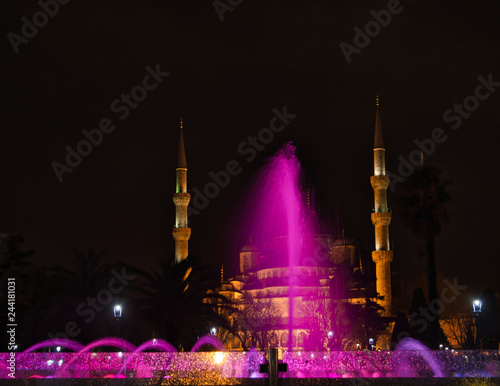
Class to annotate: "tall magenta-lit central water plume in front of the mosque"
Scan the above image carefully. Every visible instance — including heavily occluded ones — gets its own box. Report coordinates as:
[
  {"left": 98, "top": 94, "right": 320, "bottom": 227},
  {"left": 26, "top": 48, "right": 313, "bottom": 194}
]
[{"left": 235, "top": 143, "right": 318, "bottom": 350}]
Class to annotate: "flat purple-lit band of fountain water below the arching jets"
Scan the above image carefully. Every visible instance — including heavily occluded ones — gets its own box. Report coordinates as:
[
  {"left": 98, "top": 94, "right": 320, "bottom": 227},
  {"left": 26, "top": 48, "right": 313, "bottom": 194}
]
[{"left": 4, "top": 350, "right": 500, "bottom": 378}]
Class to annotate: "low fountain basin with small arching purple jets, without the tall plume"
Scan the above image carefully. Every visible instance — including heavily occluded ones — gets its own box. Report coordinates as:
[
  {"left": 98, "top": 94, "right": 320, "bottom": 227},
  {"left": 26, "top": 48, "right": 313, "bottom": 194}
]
[{"left": 0, "top": 336, "right": 500, "bottom": 385}]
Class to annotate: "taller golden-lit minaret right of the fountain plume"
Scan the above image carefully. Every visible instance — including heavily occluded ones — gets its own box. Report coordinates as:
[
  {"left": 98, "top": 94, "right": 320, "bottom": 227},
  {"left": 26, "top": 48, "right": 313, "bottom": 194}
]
[{"left": 370, "top": 95, "right": 393, "bottom": 316}]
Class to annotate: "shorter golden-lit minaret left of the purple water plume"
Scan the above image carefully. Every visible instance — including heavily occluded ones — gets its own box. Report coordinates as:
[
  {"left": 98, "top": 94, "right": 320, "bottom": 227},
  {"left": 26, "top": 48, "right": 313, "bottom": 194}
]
[{"left": 172, "top": 117, "right": 191, "bottom": 263}]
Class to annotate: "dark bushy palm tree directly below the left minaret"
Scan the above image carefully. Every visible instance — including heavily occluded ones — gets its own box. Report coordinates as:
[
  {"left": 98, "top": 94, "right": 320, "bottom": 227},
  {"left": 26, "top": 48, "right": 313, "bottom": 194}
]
[{"left": 135, "top": 257, "right": 235, "bottom": 349}]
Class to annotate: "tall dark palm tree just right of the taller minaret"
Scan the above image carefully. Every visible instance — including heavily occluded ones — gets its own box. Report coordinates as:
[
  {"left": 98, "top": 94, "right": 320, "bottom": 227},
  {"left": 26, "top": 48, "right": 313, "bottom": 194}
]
[{"left": 399, "top": 166, "right": 452, "bottom": 345}]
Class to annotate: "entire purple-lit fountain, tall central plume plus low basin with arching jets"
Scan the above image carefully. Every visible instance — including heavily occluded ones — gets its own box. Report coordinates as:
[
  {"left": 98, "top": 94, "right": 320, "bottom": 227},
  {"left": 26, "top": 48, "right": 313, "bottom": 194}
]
[{"left": 0, "top": 144, "right": 500, "bottom": 385}]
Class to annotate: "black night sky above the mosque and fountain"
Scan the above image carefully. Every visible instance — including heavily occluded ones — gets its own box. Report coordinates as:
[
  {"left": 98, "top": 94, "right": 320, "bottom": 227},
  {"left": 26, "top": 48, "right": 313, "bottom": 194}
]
[{"left": 0, "top": 0, "right": 500, "bottom": 296}]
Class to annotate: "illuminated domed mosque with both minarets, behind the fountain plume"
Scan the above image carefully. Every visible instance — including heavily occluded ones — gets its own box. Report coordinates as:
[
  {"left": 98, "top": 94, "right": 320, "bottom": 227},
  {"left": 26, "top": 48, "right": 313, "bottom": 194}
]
[{"left": 172, "top": 97, "right": 393, "bottom": 350}]
